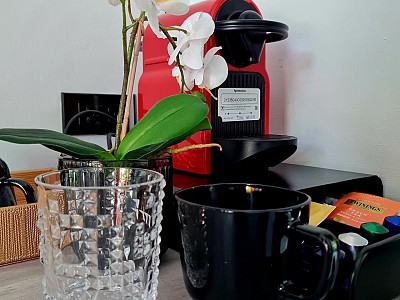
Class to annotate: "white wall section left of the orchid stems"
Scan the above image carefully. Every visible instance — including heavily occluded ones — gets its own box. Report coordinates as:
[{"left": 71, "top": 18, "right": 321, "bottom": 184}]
[{"left": 0, "top": 0, "right": 122, "bottom": 170}]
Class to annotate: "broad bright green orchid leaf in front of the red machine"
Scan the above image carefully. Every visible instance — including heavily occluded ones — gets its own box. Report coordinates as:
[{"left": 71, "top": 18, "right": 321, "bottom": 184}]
[{"left": 115, "top": 94, "right": 211, "bottom": 159}]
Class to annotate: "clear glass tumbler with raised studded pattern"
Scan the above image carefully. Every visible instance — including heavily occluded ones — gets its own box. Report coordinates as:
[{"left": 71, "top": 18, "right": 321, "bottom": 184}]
[{"left": 35, "top": 167, "right": 165, "bottom": 299}]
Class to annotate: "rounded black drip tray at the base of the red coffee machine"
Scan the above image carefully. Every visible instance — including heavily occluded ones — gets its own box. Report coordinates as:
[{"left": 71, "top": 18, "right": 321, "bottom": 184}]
[{"left": 212, "top": 134, "right": 297, "bottom": 173}]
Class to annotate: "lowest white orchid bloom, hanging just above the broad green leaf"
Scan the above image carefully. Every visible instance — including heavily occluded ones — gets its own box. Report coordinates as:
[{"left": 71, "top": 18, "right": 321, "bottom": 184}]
[{"left": 172, "top": 47, "right": 228, "bottom": 91}]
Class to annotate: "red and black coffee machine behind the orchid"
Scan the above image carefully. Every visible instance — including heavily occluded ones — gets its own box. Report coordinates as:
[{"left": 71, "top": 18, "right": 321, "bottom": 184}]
[{"left": 136, "top": 0, "right": 297, "bottom": 175}]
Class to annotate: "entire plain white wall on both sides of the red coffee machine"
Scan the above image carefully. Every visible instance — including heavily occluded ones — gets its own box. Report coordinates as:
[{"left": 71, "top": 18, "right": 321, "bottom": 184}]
[{"left": 0, "top": 0, "right": 400, "bottom": 200}]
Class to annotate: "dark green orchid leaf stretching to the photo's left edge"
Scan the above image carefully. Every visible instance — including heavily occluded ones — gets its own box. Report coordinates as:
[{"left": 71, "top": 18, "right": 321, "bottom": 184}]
[{"left": 0, "top": 128, "right": 115, "bottom": 160}]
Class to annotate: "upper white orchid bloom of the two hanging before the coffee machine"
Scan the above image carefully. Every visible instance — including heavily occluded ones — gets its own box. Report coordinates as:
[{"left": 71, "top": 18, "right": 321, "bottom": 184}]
[{"left": 168, "top": 12, "right": 215, "bottom": 69}]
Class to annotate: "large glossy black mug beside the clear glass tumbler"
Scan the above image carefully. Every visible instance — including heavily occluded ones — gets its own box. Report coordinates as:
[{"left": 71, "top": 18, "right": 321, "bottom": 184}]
[{"left": 175, "top": 183, "right": 339, "bottom": 300}]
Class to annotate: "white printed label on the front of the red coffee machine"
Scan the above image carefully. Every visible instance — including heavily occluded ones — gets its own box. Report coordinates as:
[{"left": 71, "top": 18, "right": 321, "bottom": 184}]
[{"left": 218, "top": 88, "right": 260, "bottom": 122}]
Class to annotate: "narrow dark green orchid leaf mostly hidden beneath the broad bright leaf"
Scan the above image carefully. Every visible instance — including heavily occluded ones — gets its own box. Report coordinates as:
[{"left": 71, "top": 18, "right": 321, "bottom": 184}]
[{"left": 124, "top": 118, "right": 211, "bottom": 159}]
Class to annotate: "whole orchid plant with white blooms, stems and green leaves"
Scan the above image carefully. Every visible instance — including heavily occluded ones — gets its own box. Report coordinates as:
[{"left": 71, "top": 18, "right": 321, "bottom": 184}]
[{"left": 0, "top": 0, "right": 228, "bottom": 160}]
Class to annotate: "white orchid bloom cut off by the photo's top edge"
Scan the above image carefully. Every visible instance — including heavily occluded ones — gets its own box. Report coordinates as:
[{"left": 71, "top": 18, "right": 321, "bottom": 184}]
[{"left": 136, "top": 0, "right": 189, "bottom": 38}]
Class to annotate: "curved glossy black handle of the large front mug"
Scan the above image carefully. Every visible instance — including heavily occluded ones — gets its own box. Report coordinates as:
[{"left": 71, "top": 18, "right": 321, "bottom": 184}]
[{"left": 280, "top": 224, "right": 339, "bottom": 300}]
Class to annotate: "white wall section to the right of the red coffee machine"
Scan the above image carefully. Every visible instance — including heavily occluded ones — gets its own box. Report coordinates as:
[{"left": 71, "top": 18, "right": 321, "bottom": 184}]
[{"left": 256, "top": 0, "right": 400, "bottom": 200}]
